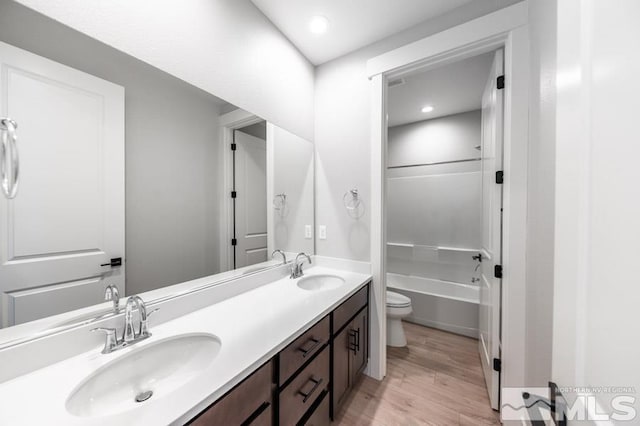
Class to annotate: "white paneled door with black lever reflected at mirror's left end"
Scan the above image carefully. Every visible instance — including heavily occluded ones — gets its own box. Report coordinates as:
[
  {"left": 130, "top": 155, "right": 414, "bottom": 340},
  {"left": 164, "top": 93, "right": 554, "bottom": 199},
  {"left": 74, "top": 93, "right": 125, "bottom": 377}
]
[{"left": 0, "top": 43, "right": 125, "bottom": 326}]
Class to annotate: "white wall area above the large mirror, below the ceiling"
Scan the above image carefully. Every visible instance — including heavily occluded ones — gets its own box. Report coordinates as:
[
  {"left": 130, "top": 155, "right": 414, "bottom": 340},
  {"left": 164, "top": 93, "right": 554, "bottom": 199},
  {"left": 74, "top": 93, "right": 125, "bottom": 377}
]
[{"left": 11, "top": 0, "right": 314, "bottom": 140}]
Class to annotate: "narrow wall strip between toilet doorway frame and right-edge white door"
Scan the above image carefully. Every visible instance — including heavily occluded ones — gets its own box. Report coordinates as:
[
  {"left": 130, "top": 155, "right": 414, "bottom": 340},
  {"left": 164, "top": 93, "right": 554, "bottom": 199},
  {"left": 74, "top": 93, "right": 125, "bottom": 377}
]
[{"left": 525, "top": 1, "right": 557, "bottom": 386}]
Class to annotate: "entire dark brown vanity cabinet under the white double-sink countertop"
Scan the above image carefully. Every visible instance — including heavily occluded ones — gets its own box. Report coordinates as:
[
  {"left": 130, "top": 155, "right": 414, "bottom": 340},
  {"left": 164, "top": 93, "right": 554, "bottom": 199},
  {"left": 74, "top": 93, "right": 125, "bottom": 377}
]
[{"left": 190, "top": 285, "right": 369, "bottom": 426}]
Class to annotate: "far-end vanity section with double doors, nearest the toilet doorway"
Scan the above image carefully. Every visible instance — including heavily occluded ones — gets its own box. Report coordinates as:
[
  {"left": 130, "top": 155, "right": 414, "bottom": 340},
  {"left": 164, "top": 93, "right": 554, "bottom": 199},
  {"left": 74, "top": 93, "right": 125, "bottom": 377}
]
[{"left": 331, "top": 286, "right": 369, "bottom": 416}]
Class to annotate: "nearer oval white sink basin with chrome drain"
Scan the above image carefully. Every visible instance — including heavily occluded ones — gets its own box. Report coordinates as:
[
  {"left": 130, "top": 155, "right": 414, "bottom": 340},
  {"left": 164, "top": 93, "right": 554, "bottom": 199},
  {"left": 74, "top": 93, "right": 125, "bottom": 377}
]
[{"left": 66, "top": 333, "right": 221, "bottom": 417}]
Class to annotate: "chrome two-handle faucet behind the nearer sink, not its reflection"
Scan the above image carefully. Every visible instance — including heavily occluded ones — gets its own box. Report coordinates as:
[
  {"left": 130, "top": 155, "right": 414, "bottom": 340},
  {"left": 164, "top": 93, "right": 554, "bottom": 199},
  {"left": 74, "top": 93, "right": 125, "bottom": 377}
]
[{"left": 91, "top": 296, "right": 158, "bottom": 354}]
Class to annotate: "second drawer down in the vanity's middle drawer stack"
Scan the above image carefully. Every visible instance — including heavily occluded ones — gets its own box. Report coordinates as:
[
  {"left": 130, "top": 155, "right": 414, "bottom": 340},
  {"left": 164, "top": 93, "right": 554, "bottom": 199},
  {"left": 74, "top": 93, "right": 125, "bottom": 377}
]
[{"left": 280, "top": 347, "right": 329, "bottom": 426}]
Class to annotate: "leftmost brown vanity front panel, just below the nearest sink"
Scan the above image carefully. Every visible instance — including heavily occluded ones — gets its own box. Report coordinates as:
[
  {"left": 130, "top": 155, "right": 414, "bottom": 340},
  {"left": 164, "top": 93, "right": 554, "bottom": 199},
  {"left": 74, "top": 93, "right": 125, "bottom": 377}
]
[{"left": 191, "top": 361, "right": 273, "bottom": 426}]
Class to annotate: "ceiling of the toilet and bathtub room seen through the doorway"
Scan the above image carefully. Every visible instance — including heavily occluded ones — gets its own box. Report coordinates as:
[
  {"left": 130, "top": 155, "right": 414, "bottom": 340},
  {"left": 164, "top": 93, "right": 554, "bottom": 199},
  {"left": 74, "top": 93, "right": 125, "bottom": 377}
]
[{"left": 387, "top": 52, "right": 493, "bottom": 127}]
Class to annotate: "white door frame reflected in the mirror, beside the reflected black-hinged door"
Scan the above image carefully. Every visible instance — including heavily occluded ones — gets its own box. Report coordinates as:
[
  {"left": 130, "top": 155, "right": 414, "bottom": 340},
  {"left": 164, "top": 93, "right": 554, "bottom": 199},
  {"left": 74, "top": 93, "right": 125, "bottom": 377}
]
[{"left": 218, "top": 108, "right": 263, "bottom": 271}]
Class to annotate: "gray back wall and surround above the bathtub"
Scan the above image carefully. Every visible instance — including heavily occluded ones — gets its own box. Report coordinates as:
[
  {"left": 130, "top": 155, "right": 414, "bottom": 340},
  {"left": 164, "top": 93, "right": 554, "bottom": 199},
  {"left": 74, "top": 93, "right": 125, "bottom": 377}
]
[{"left": 387, "top": 110, "right": 482, "bottom": 284}]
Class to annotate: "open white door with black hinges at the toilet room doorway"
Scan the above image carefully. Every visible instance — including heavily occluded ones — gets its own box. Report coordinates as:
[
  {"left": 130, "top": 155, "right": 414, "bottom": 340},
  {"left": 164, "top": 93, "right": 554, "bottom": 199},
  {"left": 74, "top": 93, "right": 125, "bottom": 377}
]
[{"left": 478, "top": 50, "right": 503, "bottom": 410}]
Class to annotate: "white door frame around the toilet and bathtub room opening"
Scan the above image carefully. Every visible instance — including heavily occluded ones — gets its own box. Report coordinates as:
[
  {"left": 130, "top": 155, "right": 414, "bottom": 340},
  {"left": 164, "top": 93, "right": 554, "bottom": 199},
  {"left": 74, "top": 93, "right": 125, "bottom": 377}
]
[{"left": 367, "top": 2, "right": 529, "bottom": 396}]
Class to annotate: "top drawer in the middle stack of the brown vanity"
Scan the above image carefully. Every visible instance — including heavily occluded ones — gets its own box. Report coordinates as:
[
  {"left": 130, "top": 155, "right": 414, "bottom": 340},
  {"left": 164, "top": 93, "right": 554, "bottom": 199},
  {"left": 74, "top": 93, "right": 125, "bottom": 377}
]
[{"left": 280, "top": 316, "right": 329, "bottom": 385}]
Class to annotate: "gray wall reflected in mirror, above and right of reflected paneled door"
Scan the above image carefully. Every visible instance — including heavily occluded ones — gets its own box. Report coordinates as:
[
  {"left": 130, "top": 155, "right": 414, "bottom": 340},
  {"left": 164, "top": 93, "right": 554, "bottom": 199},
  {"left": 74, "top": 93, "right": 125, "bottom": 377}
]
[{"left": 0, "top": 1, "right": 223, "bottom": 294}]
